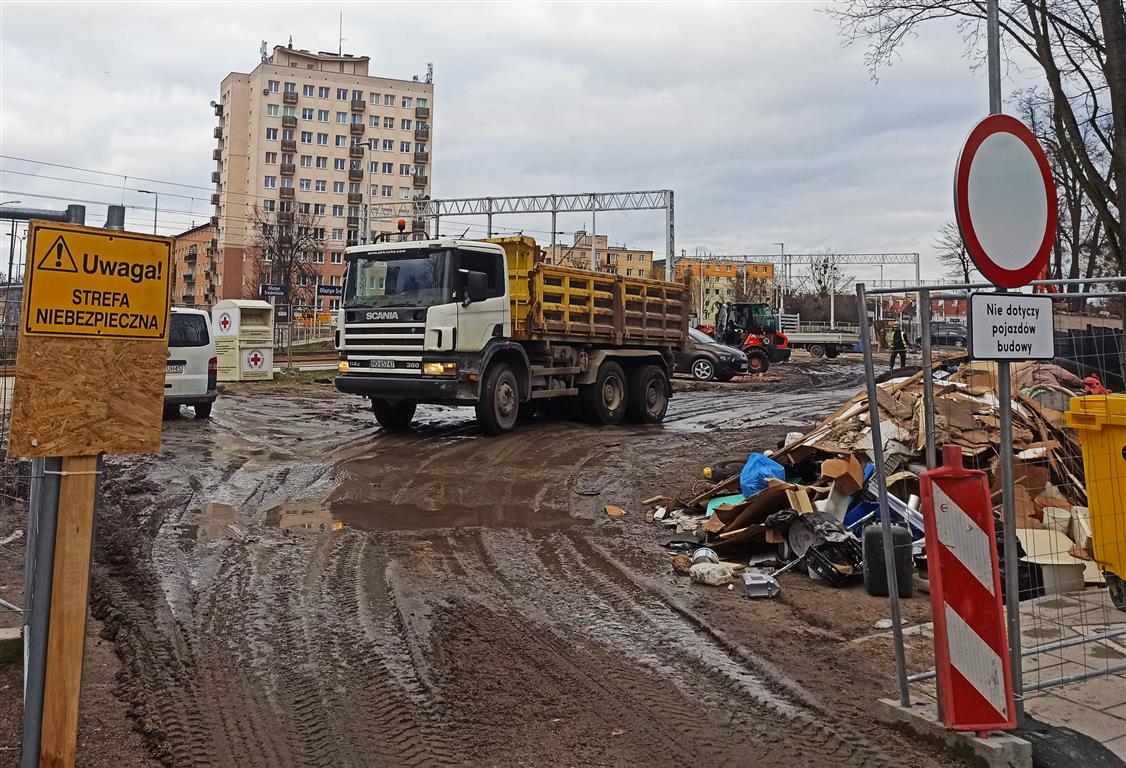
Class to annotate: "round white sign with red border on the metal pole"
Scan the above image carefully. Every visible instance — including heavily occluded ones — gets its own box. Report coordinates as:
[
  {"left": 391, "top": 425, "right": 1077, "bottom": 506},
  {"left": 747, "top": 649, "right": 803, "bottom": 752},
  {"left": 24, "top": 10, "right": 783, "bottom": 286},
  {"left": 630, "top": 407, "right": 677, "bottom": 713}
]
[{"left": 954, "top": 115, "right": 1058, "bottom": 288}]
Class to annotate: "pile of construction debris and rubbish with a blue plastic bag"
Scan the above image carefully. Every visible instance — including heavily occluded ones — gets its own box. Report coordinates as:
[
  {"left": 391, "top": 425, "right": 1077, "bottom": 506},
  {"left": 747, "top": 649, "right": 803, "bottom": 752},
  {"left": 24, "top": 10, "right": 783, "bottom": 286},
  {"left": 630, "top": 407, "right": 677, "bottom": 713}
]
[{"left": 647, "top": 359, "right": 1098, "bottom": 596}]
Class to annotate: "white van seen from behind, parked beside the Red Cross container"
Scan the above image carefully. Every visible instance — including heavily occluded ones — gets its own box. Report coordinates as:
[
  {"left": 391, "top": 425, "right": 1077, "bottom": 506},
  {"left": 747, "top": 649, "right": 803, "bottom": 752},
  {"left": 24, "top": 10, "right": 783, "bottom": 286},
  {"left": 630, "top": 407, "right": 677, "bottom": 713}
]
[{"left": 164, "top": 306, "right": 218, "bottom": 419}]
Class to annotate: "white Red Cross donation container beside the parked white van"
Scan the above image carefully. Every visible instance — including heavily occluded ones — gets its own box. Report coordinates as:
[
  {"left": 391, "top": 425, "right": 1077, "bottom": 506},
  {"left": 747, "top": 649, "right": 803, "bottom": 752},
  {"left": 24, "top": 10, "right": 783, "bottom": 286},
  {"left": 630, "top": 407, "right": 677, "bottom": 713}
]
[{"left": 212, "top": 298, "right": 274, "bottom": 382}]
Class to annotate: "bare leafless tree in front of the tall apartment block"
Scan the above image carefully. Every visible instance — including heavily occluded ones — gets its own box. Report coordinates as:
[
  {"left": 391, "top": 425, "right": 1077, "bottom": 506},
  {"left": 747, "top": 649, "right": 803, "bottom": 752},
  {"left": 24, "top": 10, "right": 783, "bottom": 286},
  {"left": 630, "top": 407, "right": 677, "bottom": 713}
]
[{"left": 247, "top": 206, "right": 324, "bottom": 305}]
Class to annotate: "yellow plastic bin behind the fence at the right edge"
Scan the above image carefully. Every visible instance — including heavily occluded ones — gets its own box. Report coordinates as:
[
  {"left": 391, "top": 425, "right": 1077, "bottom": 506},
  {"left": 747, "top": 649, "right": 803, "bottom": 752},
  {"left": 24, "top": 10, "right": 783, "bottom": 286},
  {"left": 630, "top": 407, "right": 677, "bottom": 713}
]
[{"left": 1067, "top": 394, "right": 1126, "bottom": 610}]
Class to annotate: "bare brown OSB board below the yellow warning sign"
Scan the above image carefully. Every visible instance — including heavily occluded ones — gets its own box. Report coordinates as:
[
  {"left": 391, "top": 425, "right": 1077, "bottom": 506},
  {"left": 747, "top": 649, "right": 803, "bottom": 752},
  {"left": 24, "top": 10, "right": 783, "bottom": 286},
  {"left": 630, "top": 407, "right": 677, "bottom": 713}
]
[{"left": 8, "top": 334, "right": 168, "bottom": 457}]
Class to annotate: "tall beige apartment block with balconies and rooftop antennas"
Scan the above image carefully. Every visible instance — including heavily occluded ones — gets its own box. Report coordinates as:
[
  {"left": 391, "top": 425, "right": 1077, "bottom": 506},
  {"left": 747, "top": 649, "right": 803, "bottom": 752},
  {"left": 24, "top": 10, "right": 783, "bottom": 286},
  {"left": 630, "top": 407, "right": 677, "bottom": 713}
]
[{"left": 212, "top": 45, "right": 434, "bottom": 309}]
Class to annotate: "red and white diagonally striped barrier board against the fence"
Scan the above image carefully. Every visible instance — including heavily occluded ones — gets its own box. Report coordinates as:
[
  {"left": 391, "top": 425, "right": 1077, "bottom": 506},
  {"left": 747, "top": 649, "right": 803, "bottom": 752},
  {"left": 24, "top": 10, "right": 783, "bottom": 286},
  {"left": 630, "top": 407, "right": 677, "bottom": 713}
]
[{"left": 920, "top": 446, "right": 1017, "bottom": 731}]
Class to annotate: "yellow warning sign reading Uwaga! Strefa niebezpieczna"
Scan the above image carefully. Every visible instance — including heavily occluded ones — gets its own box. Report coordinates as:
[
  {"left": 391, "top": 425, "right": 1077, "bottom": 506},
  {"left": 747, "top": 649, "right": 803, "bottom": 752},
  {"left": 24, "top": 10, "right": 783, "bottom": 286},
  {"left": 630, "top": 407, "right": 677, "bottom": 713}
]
[{"left": 24, "top": 222, "right": 172, "bottom": 339}]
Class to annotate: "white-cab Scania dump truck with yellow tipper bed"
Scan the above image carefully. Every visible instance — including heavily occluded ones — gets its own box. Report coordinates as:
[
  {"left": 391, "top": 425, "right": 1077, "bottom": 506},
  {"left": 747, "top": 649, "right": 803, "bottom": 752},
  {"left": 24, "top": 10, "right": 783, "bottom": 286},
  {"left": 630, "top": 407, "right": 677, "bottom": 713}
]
[{"left": 336, "top": 236, "right": 689, "bottom": 435}]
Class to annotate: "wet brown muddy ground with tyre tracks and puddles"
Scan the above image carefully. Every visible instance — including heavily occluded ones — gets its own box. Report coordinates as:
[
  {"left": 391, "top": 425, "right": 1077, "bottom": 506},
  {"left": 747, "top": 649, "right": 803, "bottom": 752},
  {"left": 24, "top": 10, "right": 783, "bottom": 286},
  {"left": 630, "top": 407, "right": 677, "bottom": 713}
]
[{"left": 0, "top": 361, "right": 955, "bottom": 768}]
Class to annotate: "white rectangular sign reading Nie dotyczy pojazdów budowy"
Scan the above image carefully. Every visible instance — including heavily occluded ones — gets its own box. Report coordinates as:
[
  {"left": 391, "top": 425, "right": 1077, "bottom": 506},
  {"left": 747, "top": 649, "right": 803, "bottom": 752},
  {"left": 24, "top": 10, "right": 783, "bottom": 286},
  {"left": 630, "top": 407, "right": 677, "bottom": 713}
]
[{"left": 969, "top": 293, "right": 1055, "bottom": 360}]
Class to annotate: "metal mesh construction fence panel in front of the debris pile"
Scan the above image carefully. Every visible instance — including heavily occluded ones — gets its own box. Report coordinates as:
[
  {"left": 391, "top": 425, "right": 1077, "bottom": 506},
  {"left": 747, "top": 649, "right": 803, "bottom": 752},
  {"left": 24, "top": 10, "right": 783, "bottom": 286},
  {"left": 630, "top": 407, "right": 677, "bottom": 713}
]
[{"left": 857, "top": 278, "right": 1126, "bottom": 729}]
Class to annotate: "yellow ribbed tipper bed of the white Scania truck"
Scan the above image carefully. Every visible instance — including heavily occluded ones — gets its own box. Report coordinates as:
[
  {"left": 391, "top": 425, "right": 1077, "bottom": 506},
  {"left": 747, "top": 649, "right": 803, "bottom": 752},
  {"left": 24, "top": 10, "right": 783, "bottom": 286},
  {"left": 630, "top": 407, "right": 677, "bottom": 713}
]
[{"left": 489, "top": 235, "right": 689, "bottom": 347}]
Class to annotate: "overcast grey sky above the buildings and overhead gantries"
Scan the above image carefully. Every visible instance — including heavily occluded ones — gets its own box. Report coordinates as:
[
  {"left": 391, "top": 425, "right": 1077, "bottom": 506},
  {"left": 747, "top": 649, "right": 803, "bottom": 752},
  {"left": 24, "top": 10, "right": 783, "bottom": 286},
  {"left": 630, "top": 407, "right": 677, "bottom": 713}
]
[{"left": 0, "top": 0, "right": 1008, "bottom": 278}]
